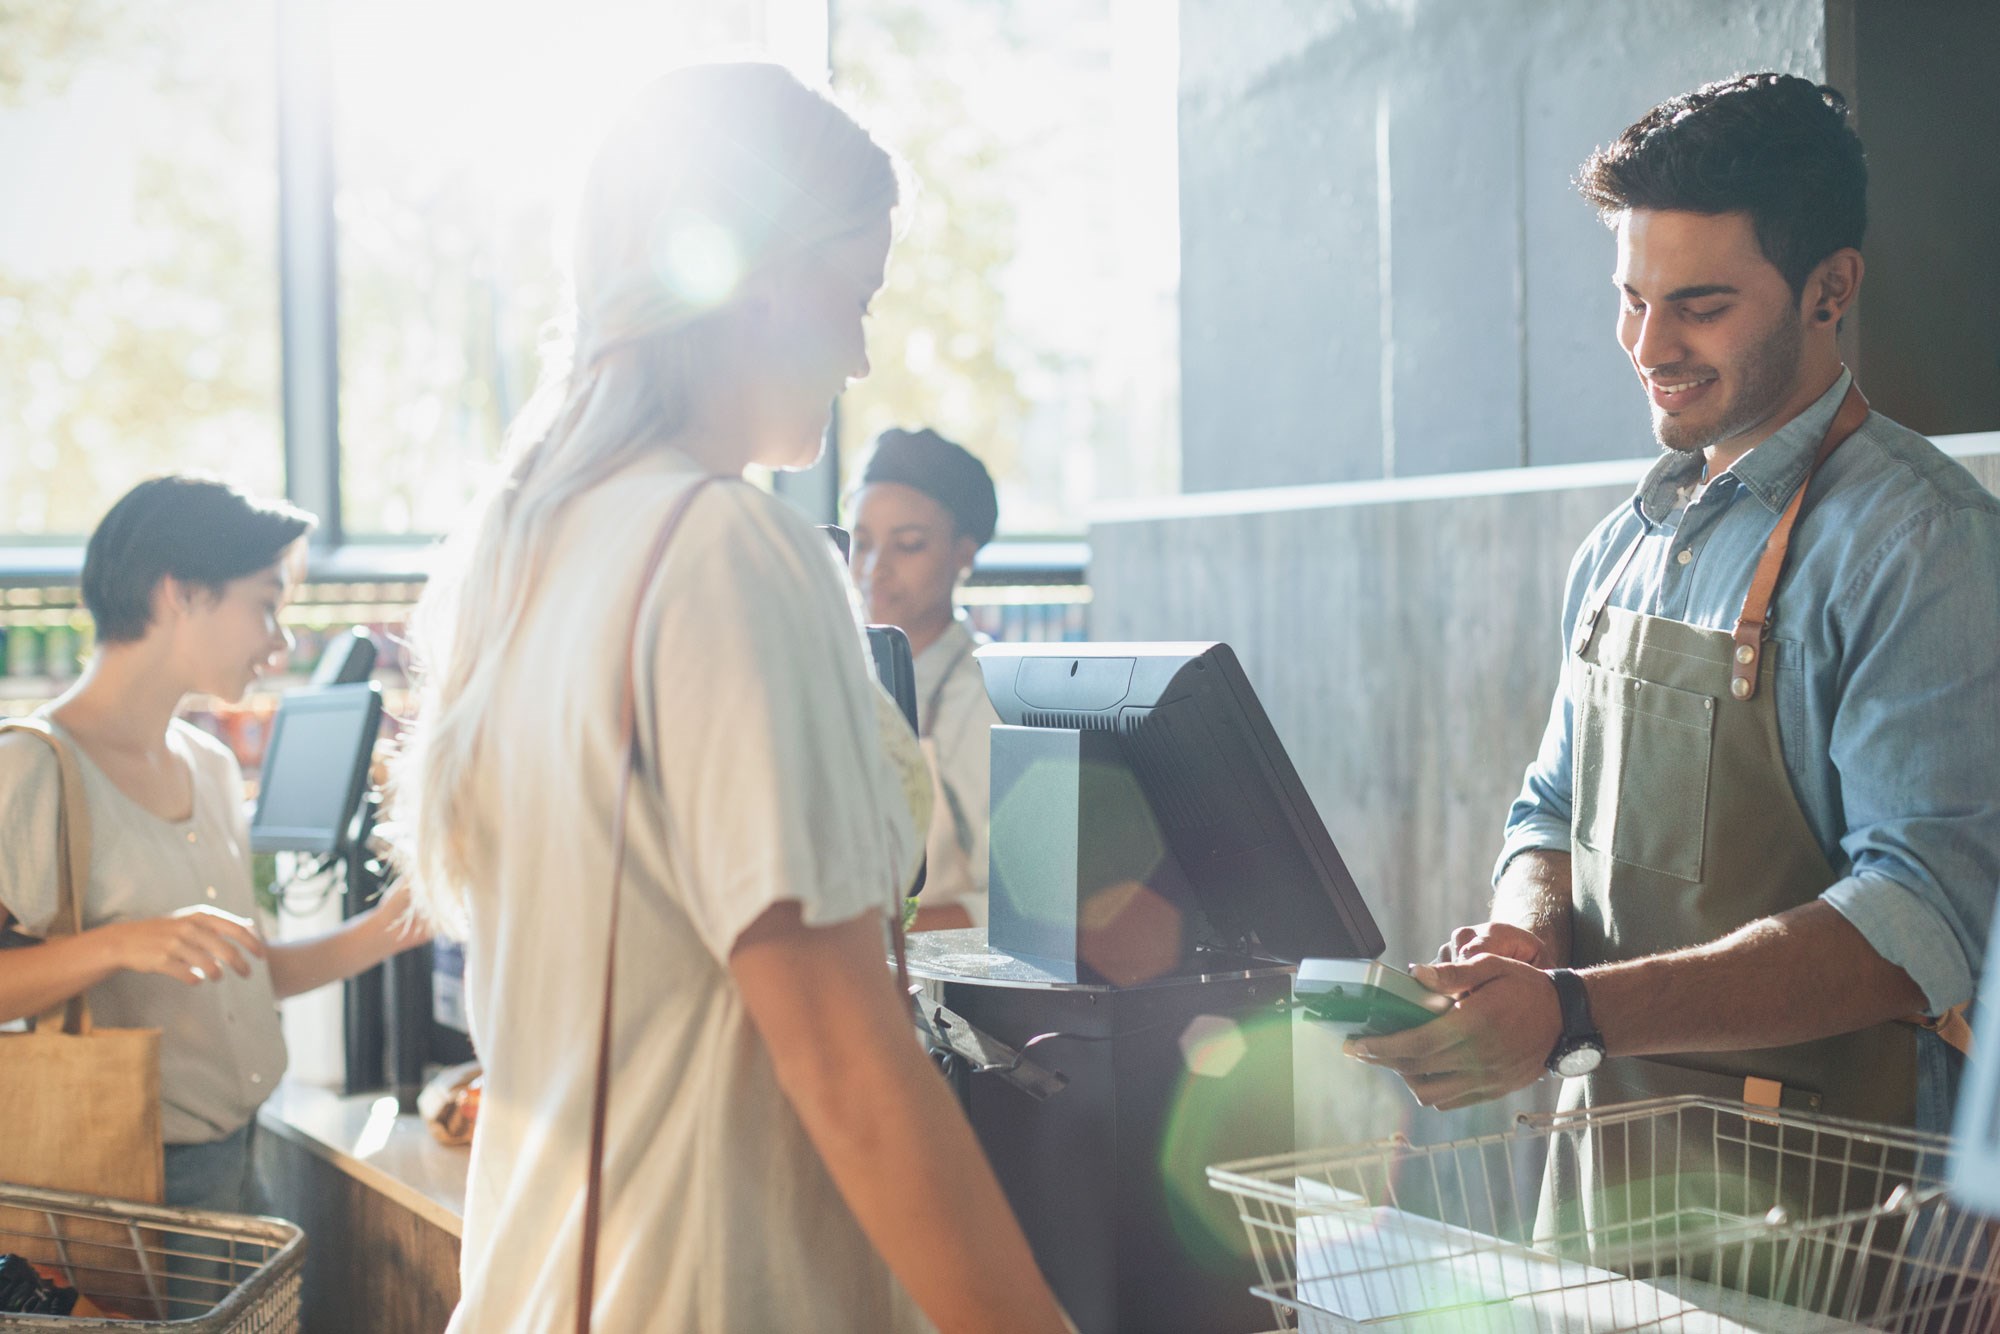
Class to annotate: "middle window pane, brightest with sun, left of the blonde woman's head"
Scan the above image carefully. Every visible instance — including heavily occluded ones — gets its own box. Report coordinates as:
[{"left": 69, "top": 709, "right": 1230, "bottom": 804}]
[{"left": 328, "top": 0, "right": 826, "bottom": 536}]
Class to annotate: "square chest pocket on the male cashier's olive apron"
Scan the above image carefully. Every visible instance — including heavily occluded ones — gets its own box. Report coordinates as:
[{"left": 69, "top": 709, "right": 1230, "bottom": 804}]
[{"left": 1574, "top": 662, "right": 1716, "bottom": 882}]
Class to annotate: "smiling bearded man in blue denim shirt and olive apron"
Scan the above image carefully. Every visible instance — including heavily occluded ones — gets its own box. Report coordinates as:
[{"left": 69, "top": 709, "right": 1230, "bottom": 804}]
[{"left": 1350, "top": 74, "right": 2000, "bottom": 1256}]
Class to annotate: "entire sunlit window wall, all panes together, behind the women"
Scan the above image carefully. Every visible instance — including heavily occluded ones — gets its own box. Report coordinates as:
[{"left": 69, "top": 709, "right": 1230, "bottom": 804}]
[{"left": 0, "top": 0, "right": 1178, "bottom": 548}]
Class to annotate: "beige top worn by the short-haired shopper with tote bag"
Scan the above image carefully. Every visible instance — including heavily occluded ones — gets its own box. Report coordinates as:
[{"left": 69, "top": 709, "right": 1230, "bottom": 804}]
[{"left": 0, "top": 720, "right": 284, "bottom": 1144}]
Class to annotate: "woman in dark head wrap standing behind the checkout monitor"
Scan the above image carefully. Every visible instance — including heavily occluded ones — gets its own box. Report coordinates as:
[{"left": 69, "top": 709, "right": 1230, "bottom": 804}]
[{"left": 852, "top": 430, "right": 1000, "bottom": 930}]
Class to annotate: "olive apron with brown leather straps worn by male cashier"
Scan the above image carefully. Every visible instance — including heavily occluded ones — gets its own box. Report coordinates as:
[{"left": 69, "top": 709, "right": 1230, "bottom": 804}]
[{"left": 1536, "top": 388, "right": 1916, "bottom": 1248}]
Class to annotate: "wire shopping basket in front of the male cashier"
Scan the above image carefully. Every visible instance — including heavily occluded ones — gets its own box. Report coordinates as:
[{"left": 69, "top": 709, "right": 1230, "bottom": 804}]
[{"left": 1208, "top": 1098, "right": 2000, "bottom": 1334}]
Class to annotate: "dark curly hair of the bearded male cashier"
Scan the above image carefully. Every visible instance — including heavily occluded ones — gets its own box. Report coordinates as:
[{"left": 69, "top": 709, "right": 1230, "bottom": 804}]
[{"left": 1576, "top": 74, "right": 1868, "bottom": 296}]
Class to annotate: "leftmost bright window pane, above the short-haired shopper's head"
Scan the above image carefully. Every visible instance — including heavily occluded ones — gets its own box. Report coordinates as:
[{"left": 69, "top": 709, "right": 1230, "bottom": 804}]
[{"left": 0, "top": 0, "right": 284, "bottom": 544}]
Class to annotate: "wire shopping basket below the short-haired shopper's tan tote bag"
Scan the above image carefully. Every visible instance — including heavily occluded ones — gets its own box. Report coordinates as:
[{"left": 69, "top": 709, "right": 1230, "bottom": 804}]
[{"left": 0, "top": 1184, "right": 306, "bottom": 1334}]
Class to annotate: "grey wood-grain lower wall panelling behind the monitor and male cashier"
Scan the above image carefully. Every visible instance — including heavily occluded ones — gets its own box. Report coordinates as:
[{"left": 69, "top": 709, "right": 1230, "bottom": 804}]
[{"left": 1090, "top": 434, "right": 2000, "bottom": 1148}]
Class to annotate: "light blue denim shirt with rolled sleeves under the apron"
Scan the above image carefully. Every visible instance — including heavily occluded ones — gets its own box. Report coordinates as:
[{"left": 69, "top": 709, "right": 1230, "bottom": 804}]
[{"left": 1494, "top": 372, "right": 2000, "bottom": 1014}]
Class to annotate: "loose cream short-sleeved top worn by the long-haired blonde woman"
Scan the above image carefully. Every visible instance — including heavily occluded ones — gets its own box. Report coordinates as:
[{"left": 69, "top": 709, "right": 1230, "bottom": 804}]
[{"left": 452, "top": 454, "right": 928, "bottom": 1334}]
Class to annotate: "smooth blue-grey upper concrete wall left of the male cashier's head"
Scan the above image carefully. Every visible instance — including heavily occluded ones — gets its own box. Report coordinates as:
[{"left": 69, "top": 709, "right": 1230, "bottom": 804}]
[{"left": 1180, "top": 0, "right": 1826, "bottom": 492}]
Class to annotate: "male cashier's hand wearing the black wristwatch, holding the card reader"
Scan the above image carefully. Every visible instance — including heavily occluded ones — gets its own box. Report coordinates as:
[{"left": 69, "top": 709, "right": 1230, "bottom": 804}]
[{"left": 1346, "top": 956, "right": 1562, "bottom": 1112}]
